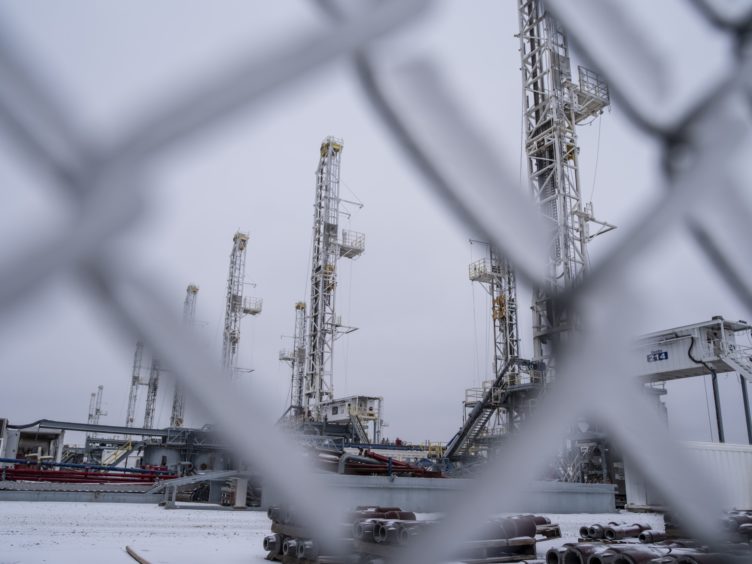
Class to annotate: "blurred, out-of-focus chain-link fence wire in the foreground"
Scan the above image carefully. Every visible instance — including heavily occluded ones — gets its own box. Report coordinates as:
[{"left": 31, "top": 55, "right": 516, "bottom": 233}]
[{"left": 0, "top": 0, "right": 752, "bottom": 564}]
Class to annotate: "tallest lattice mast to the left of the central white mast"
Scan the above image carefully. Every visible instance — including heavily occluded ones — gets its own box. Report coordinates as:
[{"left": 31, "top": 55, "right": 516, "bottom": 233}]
[{"left": 222, "top": 231, "right": 262, "bottom": 378}]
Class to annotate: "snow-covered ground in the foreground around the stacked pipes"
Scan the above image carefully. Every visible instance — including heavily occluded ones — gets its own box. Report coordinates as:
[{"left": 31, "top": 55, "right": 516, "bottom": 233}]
[{"left": 0, "top": 501, "right": 663, "bottom": 564}]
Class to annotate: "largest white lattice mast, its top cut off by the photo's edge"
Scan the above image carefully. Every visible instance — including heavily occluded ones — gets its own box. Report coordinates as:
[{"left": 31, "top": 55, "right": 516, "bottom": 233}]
[{"left": 519, "top": 0, "right": 614, "bottom": 377}]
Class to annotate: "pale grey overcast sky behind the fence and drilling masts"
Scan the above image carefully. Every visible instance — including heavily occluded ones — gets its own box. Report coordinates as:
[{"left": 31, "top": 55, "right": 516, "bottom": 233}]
[{"left": 0, "top": 0, "right": 750, "bottom": 448}]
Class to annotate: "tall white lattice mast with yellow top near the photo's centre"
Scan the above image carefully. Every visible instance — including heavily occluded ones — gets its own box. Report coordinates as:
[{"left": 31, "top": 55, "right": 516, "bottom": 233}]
[{"left": 303, "top": 137, "right": 365, "bottom": 421}]
